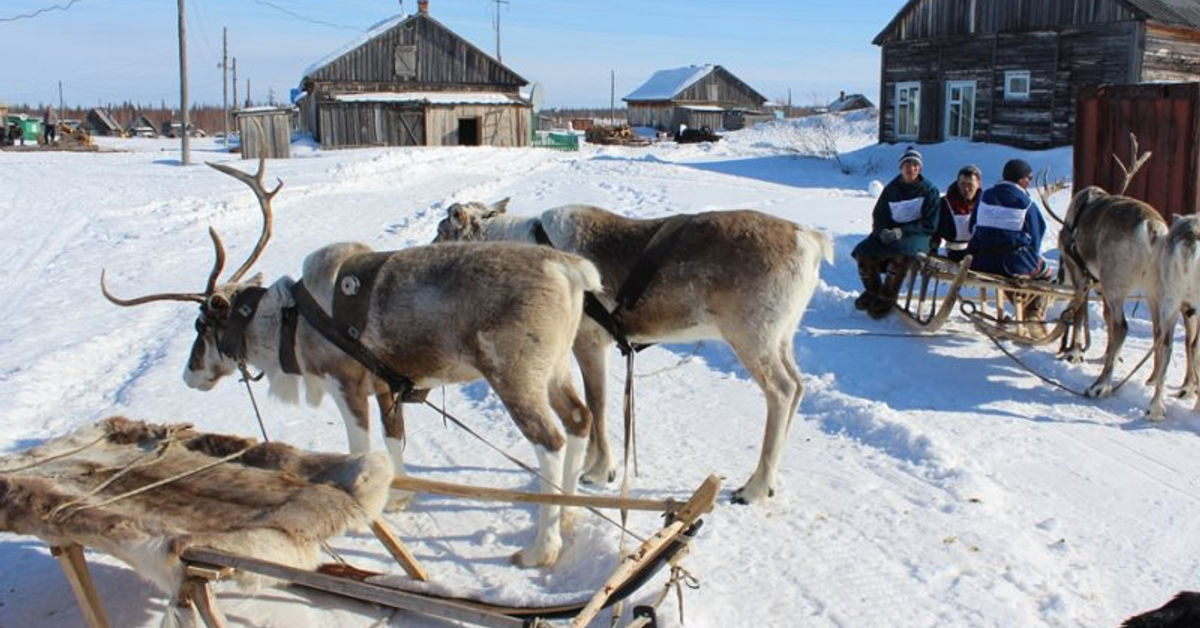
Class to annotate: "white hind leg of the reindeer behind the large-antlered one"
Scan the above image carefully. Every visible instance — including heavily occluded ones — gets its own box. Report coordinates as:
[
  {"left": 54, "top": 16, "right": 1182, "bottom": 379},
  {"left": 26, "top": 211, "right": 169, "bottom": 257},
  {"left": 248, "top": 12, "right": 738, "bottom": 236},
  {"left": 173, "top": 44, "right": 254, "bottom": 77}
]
[{"left": 726, "top": 335, "right": 799, "bottom": 504}]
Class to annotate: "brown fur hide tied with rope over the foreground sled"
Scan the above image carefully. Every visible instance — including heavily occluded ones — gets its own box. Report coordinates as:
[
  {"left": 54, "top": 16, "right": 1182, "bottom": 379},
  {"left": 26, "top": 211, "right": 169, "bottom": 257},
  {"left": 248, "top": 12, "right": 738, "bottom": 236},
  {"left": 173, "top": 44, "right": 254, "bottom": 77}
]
[{"left": 0, "top": 417, "right": 392, "bottom": 596}]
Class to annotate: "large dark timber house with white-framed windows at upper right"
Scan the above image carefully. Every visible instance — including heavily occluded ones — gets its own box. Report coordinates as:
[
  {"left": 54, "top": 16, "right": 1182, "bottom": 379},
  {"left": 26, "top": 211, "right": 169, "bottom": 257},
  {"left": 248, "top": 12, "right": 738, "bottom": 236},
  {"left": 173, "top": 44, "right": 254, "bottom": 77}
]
[{"left": 874, "top": 0, "right": 1200, "bottom": 148}]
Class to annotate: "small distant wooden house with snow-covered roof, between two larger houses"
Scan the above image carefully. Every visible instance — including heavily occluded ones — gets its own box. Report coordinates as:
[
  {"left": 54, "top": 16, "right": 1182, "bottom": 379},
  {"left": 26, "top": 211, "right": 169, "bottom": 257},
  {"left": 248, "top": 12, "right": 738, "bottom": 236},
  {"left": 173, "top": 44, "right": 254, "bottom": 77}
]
[{"left": 622, "top": 65, "right": 767, "bottom": 132}]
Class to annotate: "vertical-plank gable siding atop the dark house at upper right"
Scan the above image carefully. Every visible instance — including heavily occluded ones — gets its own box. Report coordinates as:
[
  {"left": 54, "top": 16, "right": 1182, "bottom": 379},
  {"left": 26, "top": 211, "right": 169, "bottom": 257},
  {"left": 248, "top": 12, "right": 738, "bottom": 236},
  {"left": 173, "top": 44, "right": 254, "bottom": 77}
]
[{"left": 875, "top": 0, "right": 1136, "bottom": 44}]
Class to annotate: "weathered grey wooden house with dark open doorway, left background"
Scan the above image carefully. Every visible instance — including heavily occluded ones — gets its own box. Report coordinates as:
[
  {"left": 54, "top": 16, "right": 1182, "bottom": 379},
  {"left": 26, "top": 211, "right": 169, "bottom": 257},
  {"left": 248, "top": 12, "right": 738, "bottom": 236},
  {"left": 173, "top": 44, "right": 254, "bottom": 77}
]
[{"left": 296, "top": 0, "right": 533, "bottom": 148}]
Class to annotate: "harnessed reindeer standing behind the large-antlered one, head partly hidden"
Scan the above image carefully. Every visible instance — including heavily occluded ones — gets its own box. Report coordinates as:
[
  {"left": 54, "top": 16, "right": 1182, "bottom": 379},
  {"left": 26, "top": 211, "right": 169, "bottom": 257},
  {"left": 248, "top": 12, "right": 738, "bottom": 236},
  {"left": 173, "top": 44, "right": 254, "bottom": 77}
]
[{"left": 434, "top": 199, "right": 833, "bottom": 503}]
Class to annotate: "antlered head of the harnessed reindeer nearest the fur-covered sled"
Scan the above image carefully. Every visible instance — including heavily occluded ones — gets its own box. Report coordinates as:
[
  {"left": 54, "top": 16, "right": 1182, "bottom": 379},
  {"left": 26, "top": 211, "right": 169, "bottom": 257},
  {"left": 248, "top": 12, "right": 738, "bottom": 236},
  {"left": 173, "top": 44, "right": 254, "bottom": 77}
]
[{"left": 100, "top": 159, "right": 283, "bottom": 390}]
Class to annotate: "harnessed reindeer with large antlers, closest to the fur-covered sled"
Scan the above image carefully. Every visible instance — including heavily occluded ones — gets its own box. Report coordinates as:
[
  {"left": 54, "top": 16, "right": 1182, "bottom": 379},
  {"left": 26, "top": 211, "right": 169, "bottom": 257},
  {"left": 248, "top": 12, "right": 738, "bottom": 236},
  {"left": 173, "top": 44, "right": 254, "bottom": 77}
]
[{"left": 101, "top": 161, "right": 600, "bottom": 567}]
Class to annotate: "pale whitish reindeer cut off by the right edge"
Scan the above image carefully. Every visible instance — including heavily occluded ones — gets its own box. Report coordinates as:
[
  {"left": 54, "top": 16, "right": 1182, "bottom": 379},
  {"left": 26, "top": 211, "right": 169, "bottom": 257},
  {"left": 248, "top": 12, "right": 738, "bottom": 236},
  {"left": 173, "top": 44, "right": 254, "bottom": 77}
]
[{"left": 1146, "top": 215, "right": 1200, "bottom": 420}]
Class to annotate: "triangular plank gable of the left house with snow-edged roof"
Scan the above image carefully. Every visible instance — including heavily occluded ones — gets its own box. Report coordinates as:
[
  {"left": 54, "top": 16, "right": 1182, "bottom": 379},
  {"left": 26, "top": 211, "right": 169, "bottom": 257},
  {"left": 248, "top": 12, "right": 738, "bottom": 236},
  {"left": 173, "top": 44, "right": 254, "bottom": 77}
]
[{"left": 302, "top": 13, "right": 528, "bottom": 89}]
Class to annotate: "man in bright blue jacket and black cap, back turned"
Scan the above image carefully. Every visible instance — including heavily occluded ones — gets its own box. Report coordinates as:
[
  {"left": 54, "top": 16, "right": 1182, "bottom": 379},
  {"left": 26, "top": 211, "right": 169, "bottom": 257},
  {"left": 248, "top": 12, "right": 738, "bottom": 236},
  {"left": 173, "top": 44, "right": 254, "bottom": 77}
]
[{"left": 967, "top": 160, "right": 1051, "bottom": 279}]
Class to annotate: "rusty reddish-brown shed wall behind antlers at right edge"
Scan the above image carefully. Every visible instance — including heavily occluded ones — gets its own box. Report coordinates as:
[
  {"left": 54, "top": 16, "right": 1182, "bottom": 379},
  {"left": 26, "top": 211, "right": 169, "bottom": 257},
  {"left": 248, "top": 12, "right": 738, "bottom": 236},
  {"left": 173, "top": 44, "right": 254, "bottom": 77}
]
[{"left": 1074, "top": 83, "right": 1200, "bottom": 220}]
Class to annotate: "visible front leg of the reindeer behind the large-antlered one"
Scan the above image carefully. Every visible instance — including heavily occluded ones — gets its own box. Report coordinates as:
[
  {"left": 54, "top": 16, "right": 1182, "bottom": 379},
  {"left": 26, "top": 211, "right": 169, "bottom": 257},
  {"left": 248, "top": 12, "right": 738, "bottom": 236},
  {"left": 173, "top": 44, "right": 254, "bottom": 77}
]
[{"left": 575, "top": 329, "right": 617, "bottom": 484}]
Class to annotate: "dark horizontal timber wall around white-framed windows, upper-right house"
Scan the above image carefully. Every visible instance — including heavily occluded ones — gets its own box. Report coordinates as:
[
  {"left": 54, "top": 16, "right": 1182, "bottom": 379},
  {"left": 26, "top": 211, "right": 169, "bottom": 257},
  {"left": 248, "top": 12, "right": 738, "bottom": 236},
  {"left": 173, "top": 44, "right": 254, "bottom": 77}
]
[{"left": 880, "top": 19, "right": 1141, "bottom": 148}]
